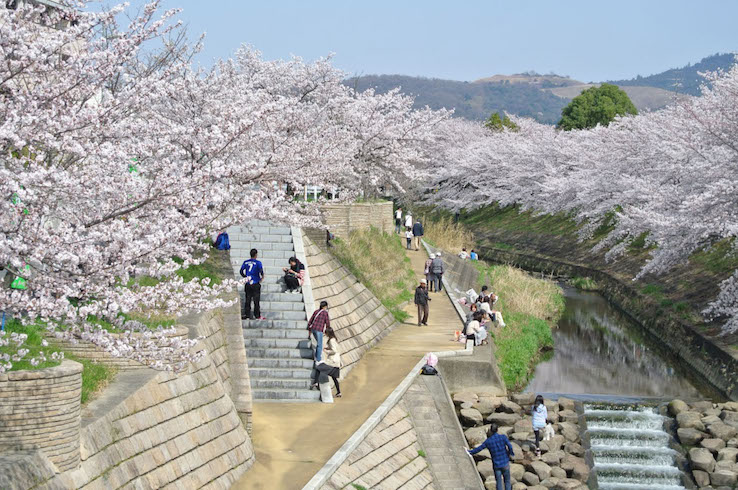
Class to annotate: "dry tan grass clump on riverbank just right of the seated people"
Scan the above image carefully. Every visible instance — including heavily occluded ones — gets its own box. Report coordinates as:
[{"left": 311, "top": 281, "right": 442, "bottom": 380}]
[{"left": 479, "top": 262, "right": 564, "bottom": 322}]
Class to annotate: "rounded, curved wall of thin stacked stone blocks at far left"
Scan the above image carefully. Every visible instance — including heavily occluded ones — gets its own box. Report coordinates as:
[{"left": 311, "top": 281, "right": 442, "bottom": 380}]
[{"left": 0, "top": 360, "right": 82, "bottom": 471}]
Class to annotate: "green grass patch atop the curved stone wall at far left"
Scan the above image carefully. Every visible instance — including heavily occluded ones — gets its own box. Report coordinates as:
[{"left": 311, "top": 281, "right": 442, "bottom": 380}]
[{"left": 0, "top": 318, "right": 116, "bottom": 404}]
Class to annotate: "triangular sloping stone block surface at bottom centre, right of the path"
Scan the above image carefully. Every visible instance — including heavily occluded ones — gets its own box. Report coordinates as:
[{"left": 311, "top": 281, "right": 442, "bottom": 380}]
[{"left": 321, "top": 401, "right": 440, "bottom": 490}]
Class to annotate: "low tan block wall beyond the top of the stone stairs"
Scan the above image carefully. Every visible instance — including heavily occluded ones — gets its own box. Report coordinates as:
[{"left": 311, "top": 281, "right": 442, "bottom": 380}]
[{"left": 305, "top": 201, "right": 395, "bottom": 247}]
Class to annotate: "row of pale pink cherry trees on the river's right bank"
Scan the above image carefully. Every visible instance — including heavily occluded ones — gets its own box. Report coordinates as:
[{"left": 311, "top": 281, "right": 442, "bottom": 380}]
[{"left": 425, "top": 66, "right": 738, "bottom": 332}]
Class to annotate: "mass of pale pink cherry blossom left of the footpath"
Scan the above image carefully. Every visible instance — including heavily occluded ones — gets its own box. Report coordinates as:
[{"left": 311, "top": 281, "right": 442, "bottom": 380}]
[{"left": 0, "top": 0, "right": 447, "bottom": 370}]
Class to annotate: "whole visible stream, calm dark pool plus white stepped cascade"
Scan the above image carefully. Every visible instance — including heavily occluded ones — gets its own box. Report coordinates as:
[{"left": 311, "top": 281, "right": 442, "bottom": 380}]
[{"left": 526, "top": 286, "right": 715, "bottom": 490}]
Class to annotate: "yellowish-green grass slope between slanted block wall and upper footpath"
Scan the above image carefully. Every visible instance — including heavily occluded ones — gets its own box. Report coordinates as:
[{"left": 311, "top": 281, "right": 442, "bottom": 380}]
[{"left": 331, "top": 227, "right": 415, "bottom": 322}]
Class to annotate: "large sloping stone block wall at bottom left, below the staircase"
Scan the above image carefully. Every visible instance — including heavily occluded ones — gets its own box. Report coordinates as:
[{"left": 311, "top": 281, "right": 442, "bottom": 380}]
[{"left": 39, "top": 357, "right": 254, "bottom": 489}]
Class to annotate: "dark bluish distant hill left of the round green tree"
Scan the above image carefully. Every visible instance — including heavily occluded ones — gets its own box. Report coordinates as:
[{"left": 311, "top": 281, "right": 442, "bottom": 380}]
[{"left": 345, "top": 75, "right": 569, "bottom": 124}]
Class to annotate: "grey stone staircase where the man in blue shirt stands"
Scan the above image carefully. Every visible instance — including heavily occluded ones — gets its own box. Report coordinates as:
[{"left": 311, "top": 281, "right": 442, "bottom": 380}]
[{"left": 228, "top": 221, "right": 320, "bottom": 401}]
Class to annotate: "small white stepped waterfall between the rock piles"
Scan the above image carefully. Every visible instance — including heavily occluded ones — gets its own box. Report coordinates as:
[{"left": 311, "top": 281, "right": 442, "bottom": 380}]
[{"left": 584, "top": 404, "right": 684, "bottom": 490}]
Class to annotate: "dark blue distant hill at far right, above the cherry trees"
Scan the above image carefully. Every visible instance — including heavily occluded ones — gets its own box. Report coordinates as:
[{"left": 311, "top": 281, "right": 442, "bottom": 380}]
[{"left": 609, "top": 53, "right": 735, "bottom": 96}]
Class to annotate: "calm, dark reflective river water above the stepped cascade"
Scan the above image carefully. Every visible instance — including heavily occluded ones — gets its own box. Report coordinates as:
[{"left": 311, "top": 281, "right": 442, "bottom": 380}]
[{"left": 526, "top": 286, "right": 700, "bottom": 398}]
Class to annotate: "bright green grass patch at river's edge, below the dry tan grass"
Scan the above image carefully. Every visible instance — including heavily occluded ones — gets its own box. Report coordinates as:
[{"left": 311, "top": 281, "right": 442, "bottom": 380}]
[{"left": 494, "top": 313, "right": 553, "bottom": 391}]
